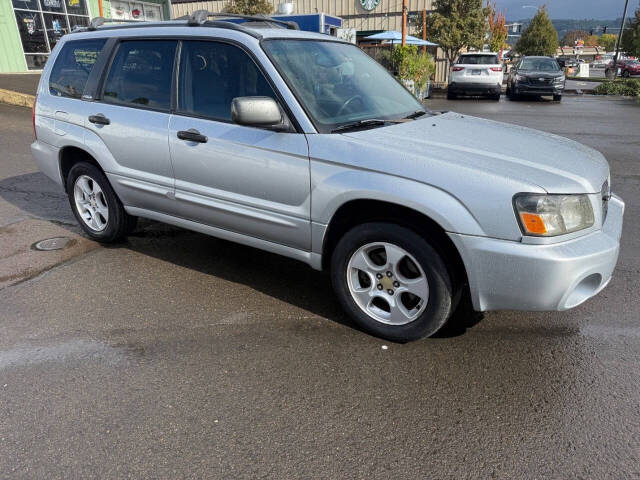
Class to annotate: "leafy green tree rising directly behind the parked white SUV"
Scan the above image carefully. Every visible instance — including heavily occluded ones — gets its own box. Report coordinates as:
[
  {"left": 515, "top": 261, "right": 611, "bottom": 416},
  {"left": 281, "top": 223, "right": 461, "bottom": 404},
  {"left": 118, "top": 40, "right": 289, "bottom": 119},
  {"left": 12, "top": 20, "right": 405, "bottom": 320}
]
[{"left": 416, "top": 0, "right": 489, "bottom": 62}]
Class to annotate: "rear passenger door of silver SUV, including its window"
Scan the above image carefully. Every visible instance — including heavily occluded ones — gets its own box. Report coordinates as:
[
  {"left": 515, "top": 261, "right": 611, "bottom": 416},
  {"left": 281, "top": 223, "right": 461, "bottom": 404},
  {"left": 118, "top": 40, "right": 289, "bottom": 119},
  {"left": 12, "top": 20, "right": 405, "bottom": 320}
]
[{"left": 85, "top": 39, "right": 178, "bottom": 213}]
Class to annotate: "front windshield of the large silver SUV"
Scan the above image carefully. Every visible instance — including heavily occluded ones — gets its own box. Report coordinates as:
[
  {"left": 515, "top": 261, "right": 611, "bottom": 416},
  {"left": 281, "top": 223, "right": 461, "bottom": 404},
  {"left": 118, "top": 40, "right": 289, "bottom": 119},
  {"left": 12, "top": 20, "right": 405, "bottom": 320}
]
[{"left": 263, "top": 39, "right": 424, "bottom": 132}]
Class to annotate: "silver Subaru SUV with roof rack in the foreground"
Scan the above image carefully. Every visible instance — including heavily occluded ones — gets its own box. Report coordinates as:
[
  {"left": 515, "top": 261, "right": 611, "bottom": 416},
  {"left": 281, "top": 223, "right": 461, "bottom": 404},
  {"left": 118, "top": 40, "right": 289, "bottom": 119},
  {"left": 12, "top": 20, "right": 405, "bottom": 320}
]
[{"left": 32, "top": 12, "right": 624, "bottom": 342}]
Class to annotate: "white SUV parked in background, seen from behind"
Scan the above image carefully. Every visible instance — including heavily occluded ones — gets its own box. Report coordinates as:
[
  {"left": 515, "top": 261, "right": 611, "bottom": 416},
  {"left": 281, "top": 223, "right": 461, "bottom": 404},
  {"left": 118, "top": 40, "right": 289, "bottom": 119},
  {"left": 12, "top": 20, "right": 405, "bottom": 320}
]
[{"left": 447, "top": 52, "right": 503, "bottom": 100}]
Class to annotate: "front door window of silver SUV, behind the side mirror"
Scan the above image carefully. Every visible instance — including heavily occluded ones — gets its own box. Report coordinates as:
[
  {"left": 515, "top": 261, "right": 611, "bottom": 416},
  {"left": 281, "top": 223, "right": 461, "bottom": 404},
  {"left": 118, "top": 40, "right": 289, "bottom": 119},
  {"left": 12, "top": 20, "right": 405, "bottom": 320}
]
[{"left": 178, "top": 40, "right": 277, "bottom": 121}]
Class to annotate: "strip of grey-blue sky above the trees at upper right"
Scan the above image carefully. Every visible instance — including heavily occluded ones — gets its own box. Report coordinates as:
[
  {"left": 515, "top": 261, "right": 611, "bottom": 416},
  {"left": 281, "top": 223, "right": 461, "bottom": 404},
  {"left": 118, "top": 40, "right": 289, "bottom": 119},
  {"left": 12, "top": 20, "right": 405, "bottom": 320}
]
[{"left": 496, "top": 0, "right": 640, "bottom": 20}]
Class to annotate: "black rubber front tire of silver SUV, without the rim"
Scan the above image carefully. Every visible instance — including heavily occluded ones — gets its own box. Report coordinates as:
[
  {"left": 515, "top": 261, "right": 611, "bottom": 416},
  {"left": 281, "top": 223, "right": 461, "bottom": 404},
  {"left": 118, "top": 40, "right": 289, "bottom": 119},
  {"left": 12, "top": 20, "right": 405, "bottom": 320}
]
[{"left": 331, "top": 223, "right": 453, "bottom": 343}]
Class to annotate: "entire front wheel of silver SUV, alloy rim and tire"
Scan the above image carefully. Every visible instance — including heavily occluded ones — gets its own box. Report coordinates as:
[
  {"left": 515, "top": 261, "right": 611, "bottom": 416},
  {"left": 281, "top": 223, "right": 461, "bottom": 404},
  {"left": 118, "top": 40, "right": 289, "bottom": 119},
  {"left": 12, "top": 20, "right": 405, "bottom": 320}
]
[{"left": 331, "top": 223, "right": 457, "bottom": 343}]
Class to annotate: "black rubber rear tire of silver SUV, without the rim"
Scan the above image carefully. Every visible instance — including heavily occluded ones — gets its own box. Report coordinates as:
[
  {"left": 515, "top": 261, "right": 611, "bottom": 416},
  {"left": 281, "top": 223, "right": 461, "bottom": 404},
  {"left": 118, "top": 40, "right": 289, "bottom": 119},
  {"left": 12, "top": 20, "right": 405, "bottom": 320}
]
[{"left": 67, "top": 162, "right": 129, "bottom": 242}]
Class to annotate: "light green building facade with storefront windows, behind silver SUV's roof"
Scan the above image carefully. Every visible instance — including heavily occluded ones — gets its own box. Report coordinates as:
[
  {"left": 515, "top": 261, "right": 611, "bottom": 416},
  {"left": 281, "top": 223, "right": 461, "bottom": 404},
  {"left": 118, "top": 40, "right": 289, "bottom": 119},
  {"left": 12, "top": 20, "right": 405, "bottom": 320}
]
[{"left": 0, "top": 0, "right": 171, "bottom": 73}]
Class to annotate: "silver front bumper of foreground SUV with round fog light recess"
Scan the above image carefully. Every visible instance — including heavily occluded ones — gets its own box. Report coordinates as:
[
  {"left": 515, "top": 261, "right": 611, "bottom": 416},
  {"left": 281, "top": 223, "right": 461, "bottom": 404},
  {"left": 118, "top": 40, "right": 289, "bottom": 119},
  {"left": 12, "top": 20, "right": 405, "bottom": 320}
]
[{"left": 449, "top": 195, "right": 624, "bottom": 311}]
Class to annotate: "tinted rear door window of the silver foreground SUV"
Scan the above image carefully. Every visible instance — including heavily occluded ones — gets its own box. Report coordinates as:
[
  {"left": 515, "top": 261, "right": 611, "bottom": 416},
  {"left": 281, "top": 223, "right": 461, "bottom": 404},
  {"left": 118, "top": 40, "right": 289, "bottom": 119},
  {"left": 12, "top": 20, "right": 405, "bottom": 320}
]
[{"left": 102, "top": 40, "right": 177, "bottom": 110}]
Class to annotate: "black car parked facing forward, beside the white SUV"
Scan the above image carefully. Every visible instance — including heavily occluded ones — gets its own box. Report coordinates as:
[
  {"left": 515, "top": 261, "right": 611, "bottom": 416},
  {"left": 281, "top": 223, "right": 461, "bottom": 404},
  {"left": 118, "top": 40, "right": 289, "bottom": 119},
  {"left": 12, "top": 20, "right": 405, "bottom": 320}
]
[{"left": 507, "top": 57, "right": 566, "bottom": 102}]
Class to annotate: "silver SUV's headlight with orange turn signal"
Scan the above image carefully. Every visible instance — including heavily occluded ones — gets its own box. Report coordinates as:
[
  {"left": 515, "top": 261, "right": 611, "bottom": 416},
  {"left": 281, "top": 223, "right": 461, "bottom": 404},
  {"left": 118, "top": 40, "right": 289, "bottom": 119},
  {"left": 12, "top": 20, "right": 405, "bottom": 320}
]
[{"left": 513, "top": 193, "right": 594, "bottom": 237}]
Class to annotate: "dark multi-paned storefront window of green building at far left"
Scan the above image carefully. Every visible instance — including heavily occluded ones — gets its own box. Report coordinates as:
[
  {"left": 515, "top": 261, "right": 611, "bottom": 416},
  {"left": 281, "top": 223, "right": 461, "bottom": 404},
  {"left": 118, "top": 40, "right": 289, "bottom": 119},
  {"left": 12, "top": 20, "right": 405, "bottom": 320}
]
[{"left": 12, "top": 0, "right": 89, "bottom": 70}]
